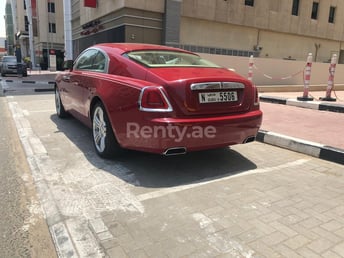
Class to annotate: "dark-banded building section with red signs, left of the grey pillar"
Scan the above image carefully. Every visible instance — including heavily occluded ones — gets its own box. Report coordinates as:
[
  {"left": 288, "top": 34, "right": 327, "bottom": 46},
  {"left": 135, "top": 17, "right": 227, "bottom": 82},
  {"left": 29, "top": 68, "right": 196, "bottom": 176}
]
[{"left": 72, "top": 0, "right": 165, "bottom": 56}]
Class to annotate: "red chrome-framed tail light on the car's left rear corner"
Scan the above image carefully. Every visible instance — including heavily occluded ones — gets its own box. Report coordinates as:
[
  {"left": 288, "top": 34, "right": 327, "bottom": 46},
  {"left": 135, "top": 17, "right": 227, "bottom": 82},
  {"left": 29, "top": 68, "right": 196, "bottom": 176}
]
[{"left": 139, "top": 86, "right": 173, "bottom": 112}]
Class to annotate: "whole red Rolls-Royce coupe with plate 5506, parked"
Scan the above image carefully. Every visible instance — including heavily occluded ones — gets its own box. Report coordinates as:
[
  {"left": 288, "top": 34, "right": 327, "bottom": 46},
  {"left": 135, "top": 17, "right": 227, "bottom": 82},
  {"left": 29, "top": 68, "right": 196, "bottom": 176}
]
[{"left": 55, "top": 43, "right": 262, "bottom": 157}]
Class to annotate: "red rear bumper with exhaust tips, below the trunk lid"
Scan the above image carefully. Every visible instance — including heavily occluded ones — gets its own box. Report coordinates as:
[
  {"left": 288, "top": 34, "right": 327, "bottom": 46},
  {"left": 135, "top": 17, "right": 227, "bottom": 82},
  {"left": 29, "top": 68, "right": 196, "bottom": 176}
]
[{"left": 117, "top": 110, "right": 262, "bottom": 154}]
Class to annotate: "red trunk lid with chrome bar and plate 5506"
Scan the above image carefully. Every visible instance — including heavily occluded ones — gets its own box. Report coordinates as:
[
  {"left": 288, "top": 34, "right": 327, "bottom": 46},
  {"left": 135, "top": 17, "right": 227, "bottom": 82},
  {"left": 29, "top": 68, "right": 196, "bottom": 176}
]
[{"left": 145, "top": 68, "right": 253, "bottom": 116}]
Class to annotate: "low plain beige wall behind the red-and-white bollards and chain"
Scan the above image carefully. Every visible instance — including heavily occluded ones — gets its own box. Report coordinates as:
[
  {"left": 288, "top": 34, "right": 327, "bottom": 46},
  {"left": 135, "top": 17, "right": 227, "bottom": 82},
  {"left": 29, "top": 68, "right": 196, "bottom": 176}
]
[{"left": 200, "top": 54, "right": 344, "bottom": 88}]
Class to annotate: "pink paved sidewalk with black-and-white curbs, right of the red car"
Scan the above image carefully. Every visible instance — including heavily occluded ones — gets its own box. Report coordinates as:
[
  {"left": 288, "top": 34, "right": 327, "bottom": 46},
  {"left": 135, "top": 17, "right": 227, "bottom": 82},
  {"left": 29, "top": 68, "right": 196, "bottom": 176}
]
[{"left": 258, "top": 91, "right": 344, "bottom": 164}]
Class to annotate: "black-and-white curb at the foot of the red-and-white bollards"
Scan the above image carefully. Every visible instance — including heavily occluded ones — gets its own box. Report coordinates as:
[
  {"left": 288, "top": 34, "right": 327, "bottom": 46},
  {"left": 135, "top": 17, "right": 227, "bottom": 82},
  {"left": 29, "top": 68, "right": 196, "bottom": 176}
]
[{"left": 259, "top": 96, "right": 344, "bottom": 113}]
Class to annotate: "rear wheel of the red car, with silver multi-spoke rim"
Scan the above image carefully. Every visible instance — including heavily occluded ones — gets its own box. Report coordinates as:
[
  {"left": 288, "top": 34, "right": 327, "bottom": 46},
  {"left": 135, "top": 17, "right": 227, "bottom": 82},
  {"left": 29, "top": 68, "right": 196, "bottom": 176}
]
[{"left": 92, "top": 102, "right": 121, "bottom": 158}]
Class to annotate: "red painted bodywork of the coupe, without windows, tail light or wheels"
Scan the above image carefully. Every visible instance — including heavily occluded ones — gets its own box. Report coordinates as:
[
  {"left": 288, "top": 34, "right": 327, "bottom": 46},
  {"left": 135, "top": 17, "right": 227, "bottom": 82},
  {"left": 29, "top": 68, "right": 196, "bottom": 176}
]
[{"left": 56, "top": 43, "right": 262, "bottom": 154}]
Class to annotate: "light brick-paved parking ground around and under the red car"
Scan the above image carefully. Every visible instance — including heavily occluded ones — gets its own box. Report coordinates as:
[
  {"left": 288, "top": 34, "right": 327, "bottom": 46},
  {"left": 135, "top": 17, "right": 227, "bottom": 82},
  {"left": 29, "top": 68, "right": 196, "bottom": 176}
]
[{"left": 0, "top": 79, "right": 344, "bottom": 258}]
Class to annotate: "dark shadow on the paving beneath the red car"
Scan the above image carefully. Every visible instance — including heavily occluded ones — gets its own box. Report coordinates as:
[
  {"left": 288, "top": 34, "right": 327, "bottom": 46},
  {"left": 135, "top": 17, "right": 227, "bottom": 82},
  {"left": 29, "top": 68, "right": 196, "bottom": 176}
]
[{"left": 51, "top": 115, "right": 257, "bottom": 188}]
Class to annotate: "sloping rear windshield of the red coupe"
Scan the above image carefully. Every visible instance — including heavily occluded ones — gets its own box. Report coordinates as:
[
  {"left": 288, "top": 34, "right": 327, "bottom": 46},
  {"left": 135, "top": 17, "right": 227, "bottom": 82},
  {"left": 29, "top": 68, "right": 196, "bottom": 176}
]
[{"left": 125, "top": 50, "right": 220, "bottom": 67}]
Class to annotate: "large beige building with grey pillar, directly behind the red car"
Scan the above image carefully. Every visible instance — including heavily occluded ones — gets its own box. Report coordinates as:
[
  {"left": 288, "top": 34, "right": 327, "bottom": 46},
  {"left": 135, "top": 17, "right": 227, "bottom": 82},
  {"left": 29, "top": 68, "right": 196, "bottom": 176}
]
[{"left": 72, "top": 0, "right": 344, "bottom": 62}]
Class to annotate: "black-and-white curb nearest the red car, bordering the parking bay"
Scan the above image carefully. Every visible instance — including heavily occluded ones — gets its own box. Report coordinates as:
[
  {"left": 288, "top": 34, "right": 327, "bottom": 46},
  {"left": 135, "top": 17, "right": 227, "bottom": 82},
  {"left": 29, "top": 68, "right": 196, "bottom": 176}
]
[{"left": 256, "top": 130, "right": 344, "bottom": 165}]
